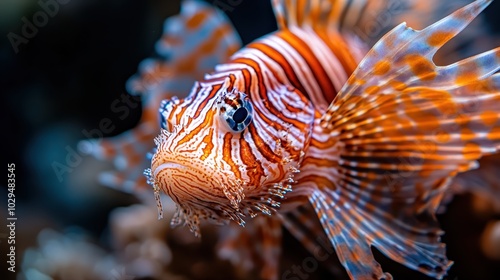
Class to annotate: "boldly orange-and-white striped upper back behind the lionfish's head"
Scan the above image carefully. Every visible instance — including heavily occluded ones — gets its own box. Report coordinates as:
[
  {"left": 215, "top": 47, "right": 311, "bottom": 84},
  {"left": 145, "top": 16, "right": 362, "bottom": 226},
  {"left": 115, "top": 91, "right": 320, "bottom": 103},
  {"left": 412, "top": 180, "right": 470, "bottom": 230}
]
[{"left": 234, "top": 27, "right": 368, "bottom": 111}]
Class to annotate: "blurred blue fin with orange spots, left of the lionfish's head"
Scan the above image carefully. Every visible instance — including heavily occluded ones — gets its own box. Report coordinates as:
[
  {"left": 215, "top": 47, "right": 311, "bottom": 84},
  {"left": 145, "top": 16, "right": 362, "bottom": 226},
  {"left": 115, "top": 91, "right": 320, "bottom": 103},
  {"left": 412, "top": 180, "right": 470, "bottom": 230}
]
[{"left": 80, "top": 0, "right": 241, "bottom": 193}]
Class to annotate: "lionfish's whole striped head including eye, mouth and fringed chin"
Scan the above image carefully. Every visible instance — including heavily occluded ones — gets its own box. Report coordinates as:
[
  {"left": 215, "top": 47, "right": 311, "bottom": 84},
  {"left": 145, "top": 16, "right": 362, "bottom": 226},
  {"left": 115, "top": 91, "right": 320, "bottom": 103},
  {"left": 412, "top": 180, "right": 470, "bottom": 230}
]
[{"left": 145, "top": 75, "right": 312, "bottom": 235}]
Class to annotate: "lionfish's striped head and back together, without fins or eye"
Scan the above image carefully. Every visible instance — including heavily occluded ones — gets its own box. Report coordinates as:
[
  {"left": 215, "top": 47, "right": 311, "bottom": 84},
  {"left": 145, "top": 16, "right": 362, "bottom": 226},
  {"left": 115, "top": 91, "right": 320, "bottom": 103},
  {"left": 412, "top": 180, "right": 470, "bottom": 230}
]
[{"left": 146, "top": 21, "right": 372, "bottom": 234}]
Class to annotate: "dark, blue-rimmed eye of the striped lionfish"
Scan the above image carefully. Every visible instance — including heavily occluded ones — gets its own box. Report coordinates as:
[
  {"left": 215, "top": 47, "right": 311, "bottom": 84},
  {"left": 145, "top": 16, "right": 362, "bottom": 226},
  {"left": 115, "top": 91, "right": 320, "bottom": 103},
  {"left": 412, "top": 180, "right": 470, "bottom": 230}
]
[{"left": 221, "top": 93, "right": 253, "bottom": 132}]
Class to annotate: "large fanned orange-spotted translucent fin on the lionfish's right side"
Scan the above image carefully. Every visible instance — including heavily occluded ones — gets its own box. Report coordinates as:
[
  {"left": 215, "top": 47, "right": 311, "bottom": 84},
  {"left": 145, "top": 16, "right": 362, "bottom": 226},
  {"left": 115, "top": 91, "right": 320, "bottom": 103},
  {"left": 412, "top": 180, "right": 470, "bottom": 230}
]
[{"left": 310, "top": 0, "right": 500, "bottom": 279}]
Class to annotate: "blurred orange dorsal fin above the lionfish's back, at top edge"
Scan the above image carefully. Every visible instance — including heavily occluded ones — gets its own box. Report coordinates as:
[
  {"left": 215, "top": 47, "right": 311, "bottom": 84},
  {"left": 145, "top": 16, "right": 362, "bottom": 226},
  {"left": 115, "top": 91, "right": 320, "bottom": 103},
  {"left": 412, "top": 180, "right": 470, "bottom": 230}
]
[{"left": 272, "top": 0, "right": 438, "bottom": 34}]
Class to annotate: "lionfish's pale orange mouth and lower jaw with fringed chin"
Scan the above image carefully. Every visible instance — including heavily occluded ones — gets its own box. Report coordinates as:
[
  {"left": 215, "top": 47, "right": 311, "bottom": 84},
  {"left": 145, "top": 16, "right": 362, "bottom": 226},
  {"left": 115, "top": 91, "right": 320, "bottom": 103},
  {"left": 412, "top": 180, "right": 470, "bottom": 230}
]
[{"left": 144, "top": 157, "right": 300, "bottom": 236}]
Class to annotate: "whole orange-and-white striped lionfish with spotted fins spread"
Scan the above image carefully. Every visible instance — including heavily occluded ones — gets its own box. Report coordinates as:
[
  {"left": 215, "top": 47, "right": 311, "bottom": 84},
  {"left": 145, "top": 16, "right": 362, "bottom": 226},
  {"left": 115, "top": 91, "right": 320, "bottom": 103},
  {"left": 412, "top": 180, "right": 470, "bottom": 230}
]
[{"left": 83, "top": 0, "right": 500, "bottom": 279}]
